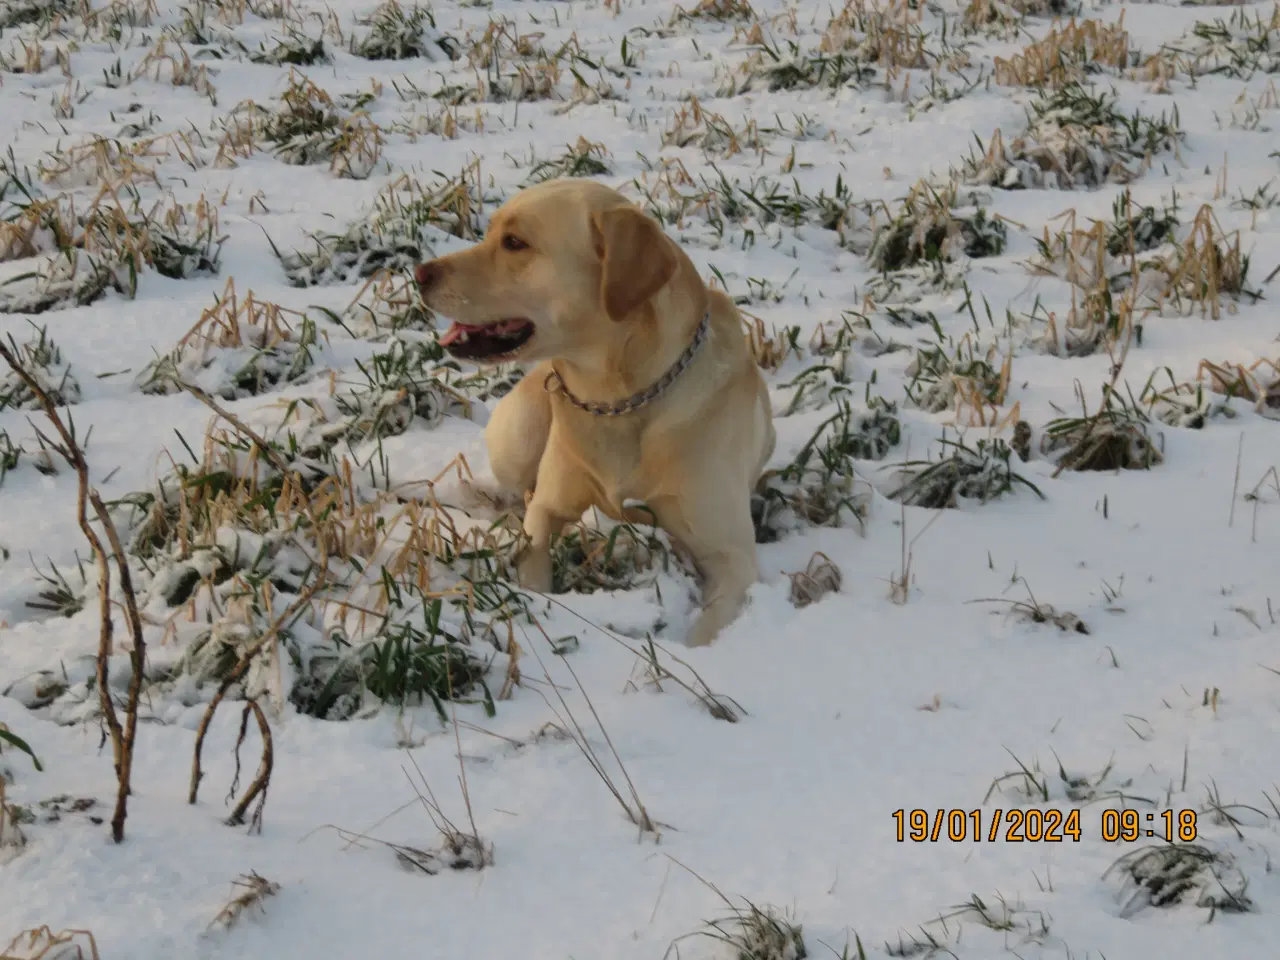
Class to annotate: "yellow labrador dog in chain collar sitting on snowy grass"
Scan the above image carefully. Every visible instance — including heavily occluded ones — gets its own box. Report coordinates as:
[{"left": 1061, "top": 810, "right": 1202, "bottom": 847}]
[{"left": 416, "top": 179, "right": 776, "bottom": 645}]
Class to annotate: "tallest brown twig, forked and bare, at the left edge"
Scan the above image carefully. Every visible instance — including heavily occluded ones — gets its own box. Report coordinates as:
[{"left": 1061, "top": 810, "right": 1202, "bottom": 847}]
[{"left": 0, "top": 343, "right": 146, "bottom": 844}]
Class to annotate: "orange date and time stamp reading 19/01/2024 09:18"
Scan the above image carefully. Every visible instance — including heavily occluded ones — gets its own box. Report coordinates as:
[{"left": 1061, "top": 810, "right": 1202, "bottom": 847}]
[{"left": 893, "top": 806, "right": 1197, "bottom": 844}]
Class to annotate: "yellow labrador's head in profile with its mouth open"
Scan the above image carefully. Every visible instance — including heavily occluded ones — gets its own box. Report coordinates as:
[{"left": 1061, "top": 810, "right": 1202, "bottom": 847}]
[{"left": 416, "top": 179, "right": 680, "bottom": 364}]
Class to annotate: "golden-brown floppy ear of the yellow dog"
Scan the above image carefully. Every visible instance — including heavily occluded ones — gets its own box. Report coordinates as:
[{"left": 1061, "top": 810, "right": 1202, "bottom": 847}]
[{"left": 591, "top": 206, "right": 680, "bottom": 320}]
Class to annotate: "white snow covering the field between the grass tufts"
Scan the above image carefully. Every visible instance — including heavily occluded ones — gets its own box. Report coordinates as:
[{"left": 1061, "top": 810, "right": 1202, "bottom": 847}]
[{"left": 0, "top": 0, "right": 1280, "bottom": 960}]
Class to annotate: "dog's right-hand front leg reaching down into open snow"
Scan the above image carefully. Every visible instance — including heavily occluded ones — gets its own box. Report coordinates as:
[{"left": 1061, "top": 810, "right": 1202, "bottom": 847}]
[{"left": 652, "top": 490, "right": 760, "bottom": 646}]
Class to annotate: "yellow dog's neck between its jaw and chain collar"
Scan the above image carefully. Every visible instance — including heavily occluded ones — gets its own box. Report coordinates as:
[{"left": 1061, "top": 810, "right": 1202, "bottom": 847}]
[{"left": 552, "top": 279, "right": 710, "bottom": 415}]
